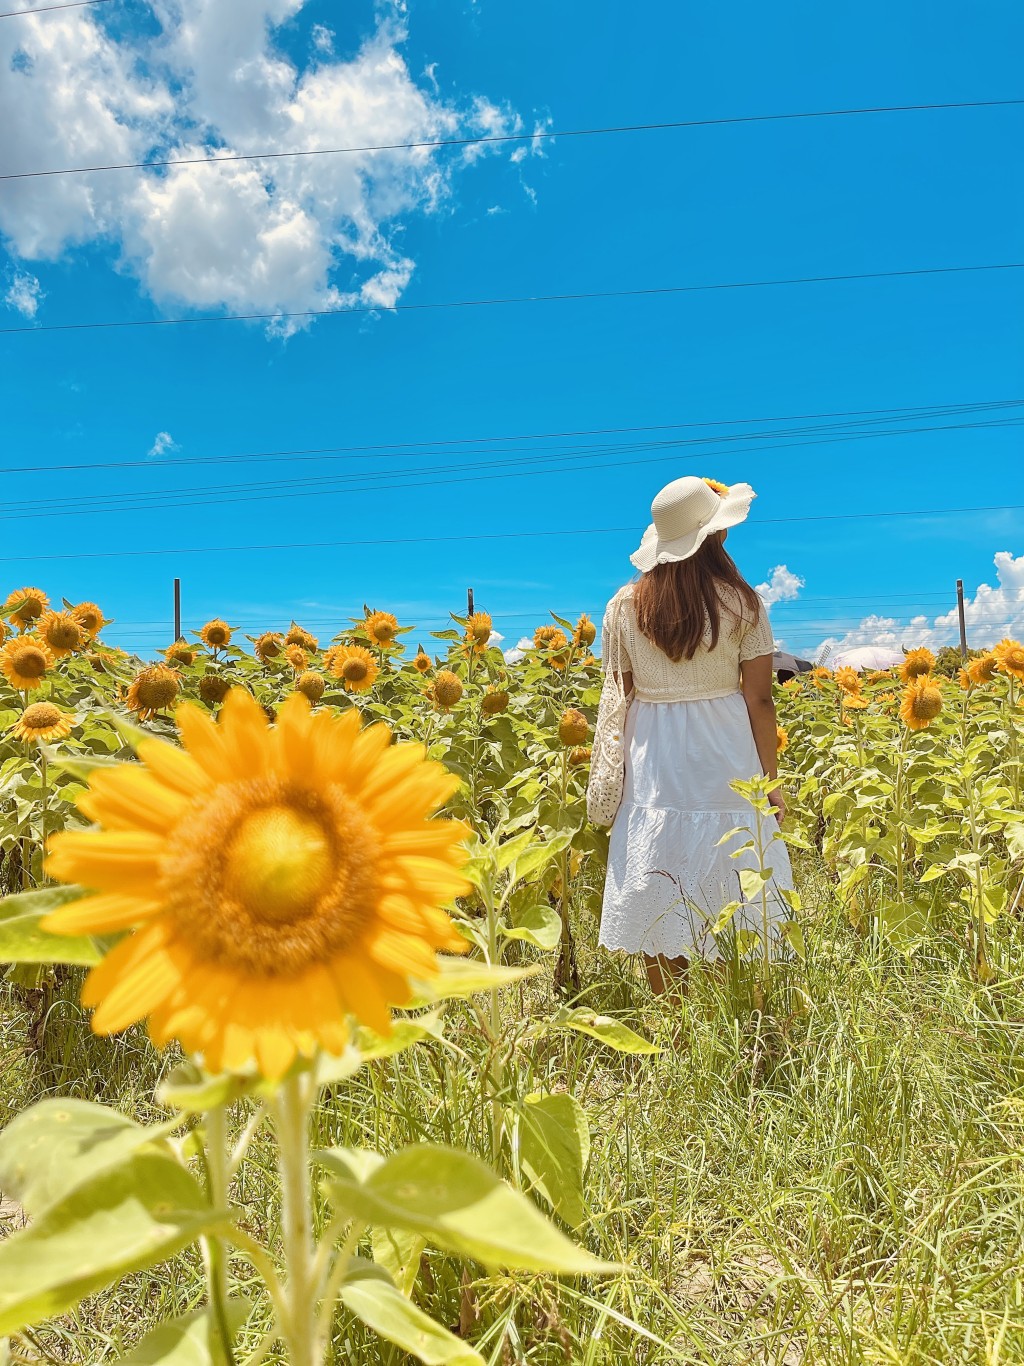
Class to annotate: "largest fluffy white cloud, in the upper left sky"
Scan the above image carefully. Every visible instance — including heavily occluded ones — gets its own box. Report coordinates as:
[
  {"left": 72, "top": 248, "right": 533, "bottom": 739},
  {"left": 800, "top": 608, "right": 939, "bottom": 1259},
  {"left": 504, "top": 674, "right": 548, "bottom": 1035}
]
[{"left": 0, "top": 0, "right": 522, "bottom": 332}]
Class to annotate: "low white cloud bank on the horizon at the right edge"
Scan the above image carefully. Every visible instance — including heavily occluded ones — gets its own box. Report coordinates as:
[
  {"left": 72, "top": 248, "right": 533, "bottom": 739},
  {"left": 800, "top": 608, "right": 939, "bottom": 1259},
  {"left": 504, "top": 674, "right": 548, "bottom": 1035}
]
[{"left": 821, "top": 550, "right": 1024, "bottom": 653}]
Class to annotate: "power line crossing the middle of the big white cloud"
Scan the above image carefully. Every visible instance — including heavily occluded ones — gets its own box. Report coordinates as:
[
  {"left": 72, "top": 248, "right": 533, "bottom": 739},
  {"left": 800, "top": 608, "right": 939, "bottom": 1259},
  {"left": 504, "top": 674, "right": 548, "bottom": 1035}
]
[{"left": 0, "top": 96, "right": 1024, "bottom": 180}]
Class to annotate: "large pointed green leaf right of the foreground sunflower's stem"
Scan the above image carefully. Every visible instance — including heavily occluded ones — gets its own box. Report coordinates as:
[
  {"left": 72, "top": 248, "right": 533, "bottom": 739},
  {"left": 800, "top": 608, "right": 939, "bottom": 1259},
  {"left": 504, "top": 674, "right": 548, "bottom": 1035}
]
[{"left": 319, "top": 1143, "right": 618, "bottom": 1274}]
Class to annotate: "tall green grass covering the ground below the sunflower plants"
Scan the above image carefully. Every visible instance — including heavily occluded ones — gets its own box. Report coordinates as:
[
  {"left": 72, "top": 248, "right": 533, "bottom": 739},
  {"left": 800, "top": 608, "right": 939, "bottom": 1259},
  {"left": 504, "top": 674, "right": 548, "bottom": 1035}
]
[{"left": 0, "top": 877, "right": 1024, "bottom": 1366}]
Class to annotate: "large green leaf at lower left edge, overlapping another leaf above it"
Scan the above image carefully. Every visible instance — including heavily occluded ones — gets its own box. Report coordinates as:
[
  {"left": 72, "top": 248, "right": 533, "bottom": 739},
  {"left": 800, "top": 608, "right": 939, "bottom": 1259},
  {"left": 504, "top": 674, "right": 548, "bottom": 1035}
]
[{"left": 0, "top": 1152, "right": 231, "bottom": 1333}]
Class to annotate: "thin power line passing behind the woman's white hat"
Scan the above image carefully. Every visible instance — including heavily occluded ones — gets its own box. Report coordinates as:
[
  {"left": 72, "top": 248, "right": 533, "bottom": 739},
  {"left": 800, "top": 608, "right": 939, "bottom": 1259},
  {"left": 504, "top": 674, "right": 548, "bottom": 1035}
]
[{"left": 0, "top": 503, "right": 1024, "bottom": 564}]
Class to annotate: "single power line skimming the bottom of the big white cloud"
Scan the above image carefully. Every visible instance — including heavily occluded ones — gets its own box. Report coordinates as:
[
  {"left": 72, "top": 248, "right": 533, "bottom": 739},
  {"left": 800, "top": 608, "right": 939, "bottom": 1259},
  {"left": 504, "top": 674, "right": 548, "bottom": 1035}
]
[{"left": 0, "top": 261, "right": 1024, "bottom": 336}]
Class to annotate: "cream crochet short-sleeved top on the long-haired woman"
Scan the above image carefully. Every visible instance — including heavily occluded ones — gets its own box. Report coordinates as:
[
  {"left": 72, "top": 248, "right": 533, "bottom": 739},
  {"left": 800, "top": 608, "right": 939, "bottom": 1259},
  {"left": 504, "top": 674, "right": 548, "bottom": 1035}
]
[{"left": 601, "top": 583, "right": 774, "bottom": 702}]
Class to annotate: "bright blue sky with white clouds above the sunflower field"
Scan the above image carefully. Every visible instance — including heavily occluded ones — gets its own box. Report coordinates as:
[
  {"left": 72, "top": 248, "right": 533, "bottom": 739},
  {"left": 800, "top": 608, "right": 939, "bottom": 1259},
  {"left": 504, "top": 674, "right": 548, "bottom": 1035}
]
[{"left": 0, "top": 0, "right": 1024, "bottom": 653}]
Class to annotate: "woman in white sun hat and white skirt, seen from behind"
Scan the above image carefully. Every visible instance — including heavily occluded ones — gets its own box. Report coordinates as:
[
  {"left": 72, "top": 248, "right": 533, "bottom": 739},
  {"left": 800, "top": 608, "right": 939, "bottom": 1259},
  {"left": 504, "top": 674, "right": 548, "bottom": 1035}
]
[{"left": 601, "top": 478, "right": 792, "bottom": 992}]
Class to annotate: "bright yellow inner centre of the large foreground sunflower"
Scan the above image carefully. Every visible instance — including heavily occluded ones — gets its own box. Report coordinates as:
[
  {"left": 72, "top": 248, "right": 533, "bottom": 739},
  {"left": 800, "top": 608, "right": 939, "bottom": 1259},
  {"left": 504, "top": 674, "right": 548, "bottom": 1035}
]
[{"left": 224, "top": 806, "right": 332, "bottom": 923}]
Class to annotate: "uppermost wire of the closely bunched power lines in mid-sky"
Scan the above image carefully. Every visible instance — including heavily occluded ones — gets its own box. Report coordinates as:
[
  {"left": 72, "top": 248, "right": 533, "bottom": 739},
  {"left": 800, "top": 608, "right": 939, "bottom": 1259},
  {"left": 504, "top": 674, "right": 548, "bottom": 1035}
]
[{"left": 0, "top": 399, "right": 1024, "bottom": 475}]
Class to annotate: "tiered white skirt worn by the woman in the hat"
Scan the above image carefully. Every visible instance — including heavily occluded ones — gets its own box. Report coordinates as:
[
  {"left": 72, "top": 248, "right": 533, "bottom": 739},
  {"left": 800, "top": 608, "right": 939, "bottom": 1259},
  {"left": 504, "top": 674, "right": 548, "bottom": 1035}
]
[{"left": 601, "top": 693, "right": 793, "bottom": 959}]
